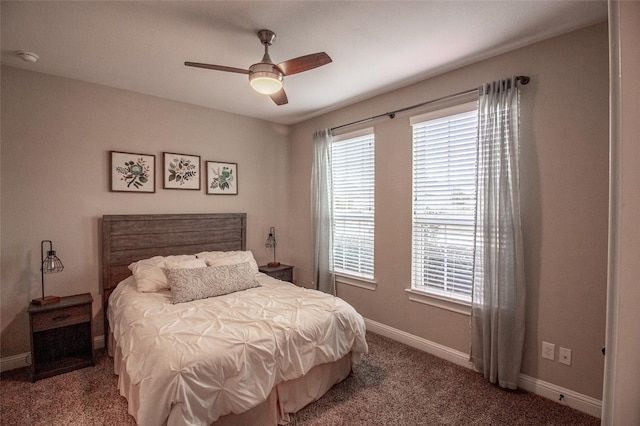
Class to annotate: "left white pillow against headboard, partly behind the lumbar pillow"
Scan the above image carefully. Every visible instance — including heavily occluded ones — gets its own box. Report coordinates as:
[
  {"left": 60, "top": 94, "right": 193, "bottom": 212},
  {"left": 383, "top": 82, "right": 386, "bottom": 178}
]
[{"left": 129, "top": 255, "right": 207, "bottom": 293}]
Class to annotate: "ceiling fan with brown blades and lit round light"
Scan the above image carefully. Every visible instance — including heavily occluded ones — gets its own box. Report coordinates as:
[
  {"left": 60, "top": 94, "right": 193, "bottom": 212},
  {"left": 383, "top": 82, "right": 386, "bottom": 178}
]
[{"left": 184, "top": 30, "right": 331, "bottom": 105}]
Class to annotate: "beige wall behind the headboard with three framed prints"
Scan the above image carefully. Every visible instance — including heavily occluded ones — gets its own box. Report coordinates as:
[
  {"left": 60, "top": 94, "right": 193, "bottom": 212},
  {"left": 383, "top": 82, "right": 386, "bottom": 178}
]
[{"left": 0, "top": 67, "right": 291, "bottom": 357}]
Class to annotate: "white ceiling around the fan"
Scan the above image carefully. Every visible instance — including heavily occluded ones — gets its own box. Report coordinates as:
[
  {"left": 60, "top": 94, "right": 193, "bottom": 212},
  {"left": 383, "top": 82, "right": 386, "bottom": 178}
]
[{"left": 1, "top": 0, "right": 607, "bottom": 124}]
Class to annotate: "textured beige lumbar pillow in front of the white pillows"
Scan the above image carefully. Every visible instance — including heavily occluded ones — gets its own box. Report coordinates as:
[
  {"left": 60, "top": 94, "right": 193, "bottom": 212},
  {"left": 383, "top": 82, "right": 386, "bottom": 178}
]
[{"left": 167, "top": 262, "right": 260, "bottom": 304}]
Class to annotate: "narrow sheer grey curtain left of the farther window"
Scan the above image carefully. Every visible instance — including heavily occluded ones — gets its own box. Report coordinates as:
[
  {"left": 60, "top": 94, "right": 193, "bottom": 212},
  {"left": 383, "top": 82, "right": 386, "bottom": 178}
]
[{"left": 311, "top": 129, "right": 336, "bottom": 296}]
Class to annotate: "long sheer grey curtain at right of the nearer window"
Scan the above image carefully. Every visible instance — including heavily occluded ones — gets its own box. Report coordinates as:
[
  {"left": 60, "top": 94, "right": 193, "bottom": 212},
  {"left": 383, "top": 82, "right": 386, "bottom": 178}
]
[{"left": 471, "top": 78, "right": 526, "bottom": 389}]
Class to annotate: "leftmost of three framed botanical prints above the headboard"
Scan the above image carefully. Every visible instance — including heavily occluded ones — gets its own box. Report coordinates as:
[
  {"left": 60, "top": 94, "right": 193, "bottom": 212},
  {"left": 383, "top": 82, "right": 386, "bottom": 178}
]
[{"left": 109, "top": 151, "right": 156, "bottom": 193}]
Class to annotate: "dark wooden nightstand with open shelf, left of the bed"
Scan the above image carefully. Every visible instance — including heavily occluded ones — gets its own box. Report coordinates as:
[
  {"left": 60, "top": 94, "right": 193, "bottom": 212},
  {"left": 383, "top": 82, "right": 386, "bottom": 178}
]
[{"left": 29, "top": 293, "right": 95, "bottom": 382}]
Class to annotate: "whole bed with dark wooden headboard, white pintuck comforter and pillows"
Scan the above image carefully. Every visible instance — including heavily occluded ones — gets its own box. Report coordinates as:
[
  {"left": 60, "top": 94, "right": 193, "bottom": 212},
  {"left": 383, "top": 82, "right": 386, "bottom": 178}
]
[{"left": 102, "top": 213, "right": 367, "bottom": 426}]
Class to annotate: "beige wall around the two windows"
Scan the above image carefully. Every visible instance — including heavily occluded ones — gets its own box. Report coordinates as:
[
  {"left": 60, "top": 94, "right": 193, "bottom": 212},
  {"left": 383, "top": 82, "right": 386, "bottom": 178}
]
[{"left": 290, "top": 24, "right": 608, "bottom": 399}]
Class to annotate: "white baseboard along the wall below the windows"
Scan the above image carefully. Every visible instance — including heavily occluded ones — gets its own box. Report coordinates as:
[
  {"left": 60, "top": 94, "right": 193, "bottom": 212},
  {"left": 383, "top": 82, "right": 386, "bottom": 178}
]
[{"left": 365, "top": 318, "right": 602, "bottom": 418}]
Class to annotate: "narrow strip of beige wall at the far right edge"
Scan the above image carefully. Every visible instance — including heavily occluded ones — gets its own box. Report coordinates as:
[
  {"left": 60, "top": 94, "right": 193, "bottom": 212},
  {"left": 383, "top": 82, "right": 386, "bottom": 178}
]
[{"left": 602, "top": 1, "right": 640, "bottom": 426}]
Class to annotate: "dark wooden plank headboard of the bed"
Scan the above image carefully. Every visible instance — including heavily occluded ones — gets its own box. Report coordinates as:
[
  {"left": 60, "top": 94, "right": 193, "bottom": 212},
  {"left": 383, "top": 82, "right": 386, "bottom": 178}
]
[{"left": 102, "top": 213, "right": 247, "bottom": 336}]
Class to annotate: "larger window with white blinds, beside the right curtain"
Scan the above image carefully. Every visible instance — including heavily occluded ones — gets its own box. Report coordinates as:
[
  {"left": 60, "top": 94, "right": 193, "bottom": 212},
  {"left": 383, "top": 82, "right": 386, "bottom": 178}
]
[{"left": 411, "top": 102, "right": 477, "bottom": 303}]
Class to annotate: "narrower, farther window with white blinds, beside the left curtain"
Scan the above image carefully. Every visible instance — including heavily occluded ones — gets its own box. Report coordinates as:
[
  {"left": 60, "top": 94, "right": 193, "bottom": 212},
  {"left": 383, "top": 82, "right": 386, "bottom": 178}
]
[{"left": 331, "top": 129, "right": 375, "bottom": 279}]
